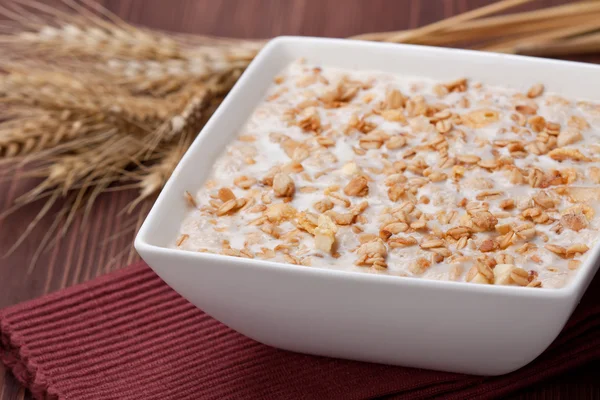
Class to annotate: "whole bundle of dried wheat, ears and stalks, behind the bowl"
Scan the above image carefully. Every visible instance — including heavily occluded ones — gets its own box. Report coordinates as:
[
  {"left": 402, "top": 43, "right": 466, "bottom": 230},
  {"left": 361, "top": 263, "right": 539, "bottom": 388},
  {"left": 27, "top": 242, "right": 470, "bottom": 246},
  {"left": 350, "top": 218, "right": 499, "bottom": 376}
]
[{"left": 0, "top": 0, "right": 600, "bottom": 270}]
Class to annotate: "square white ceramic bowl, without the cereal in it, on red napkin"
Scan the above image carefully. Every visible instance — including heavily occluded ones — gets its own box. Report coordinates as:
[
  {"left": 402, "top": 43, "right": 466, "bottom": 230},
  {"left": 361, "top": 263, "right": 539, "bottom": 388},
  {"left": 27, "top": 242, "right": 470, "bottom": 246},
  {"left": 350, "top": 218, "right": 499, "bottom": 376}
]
[{"left": 135, "top": 37, "right": 600, "bottom": 375}]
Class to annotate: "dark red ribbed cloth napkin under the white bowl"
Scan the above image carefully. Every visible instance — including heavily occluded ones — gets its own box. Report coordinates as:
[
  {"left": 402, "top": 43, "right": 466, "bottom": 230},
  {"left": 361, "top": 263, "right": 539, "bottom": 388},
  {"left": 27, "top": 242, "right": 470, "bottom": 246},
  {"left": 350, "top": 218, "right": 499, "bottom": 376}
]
[{"left": 0, "top": 263, "right": 600, "bottom": 400}]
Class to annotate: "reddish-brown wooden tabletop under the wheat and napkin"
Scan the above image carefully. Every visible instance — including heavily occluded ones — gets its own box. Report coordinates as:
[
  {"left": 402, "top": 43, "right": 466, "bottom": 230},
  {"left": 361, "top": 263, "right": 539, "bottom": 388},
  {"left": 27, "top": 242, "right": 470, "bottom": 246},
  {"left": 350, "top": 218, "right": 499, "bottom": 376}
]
[{"left": 0, "top": 0, "right": 600, "bottom": 400}]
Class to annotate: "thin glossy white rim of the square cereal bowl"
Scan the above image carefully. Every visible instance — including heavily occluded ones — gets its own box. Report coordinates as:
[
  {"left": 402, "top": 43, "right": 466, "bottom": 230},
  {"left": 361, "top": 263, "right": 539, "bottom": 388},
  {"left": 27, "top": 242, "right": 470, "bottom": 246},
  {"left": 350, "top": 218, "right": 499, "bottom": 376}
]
[{"left": 134, "top": 36, "right": 600, "bottom": 299}]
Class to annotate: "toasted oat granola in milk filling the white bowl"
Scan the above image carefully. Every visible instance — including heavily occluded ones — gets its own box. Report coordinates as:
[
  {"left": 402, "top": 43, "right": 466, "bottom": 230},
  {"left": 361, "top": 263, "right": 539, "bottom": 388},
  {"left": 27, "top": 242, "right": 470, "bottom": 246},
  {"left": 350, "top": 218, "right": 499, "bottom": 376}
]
[{"left": 174, "top": 61, "right": 600, "bottom": 287}]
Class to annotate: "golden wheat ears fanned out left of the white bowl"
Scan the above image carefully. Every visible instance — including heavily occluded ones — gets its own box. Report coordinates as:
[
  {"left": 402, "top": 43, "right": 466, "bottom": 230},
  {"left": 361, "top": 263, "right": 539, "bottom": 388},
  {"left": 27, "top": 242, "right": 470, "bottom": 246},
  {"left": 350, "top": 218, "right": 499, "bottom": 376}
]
[{"left": 0, "top": 0, "right": 255, "bottom": 266}]
